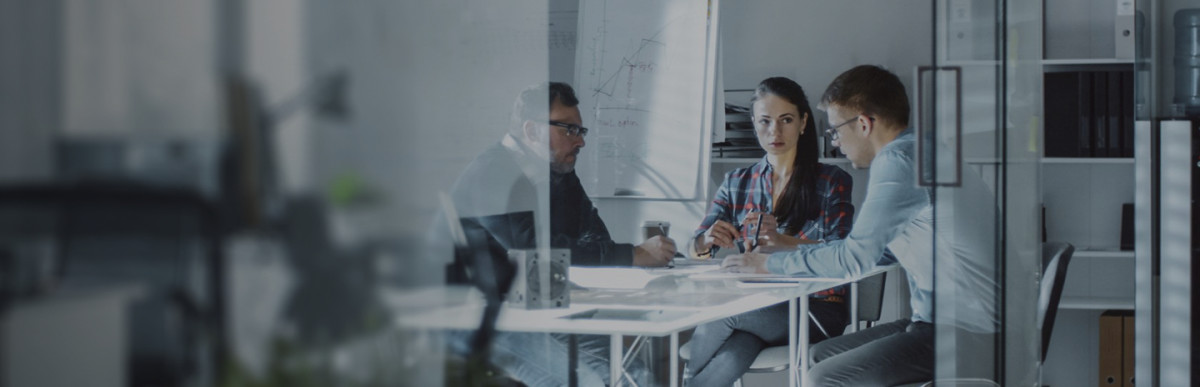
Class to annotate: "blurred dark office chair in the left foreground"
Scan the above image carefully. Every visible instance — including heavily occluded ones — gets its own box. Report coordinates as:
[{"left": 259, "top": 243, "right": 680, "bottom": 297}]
[{"left": 0, "top": 183, "right": 224, "bottom": 386}]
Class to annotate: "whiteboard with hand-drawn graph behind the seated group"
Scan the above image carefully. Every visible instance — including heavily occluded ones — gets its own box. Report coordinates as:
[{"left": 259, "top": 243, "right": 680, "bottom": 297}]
[{"left": 575, "top": 0, "right": 715, "bottom": 198}]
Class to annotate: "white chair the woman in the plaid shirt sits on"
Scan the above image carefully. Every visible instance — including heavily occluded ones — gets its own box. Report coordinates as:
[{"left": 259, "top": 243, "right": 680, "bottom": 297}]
[{"left": 679, "top": 272, "right": 888, "bottom": 386}]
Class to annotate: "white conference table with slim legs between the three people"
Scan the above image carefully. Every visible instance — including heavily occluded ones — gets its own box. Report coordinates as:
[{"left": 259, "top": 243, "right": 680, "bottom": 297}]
[{"left": 395, "top": 266, "right": 892, "bottom": 387}]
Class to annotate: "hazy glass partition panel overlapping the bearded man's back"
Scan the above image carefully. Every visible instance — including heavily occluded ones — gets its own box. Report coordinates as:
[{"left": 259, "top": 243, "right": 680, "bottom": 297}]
[{"left": 304, "top": 0, "right": 556, "bottom": 386}]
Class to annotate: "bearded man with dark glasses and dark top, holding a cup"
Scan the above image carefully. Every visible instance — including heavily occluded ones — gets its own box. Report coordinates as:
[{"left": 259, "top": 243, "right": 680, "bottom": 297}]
[{"left": 448, "top": 82, "right": 676, "bottom": 386}]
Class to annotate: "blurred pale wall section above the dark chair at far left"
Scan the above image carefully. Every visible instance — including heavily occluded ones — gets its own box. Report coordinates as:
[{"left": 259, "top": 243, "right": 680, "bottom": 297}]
[{"left": 61, "top": 0, "right": 222, "bottom": 136}]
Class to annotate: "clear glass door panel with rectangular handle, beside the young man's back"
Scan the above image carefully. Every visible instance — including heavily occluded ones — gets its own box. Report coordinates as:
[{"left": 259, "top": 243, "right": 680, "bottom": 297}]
[{"left": 926, "top": 0, "right": 1042, "bottom": 386}]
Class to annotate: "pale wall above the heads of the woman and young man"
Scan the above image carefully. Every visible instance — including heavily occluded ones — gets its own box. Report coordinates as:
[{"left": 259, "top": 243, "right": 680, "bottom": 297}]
[{"left": 721, "top": 0, "right": 932, "bottom": 111}]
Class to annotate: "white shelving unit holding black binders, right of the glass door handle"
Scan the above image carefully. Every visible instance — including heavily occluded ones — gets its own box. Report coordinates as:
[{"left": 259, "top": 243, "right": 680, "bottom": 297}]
[{"left": 1042, "top": 0, "right": 1136, "bottom": 387}]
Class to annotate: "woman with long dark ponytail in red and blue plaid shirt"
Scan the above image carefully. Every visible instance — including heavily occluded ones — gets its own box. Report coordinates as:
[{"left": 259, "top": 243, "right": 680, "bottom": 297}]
[{"left": 686, "top": 77, "right": 854, "bottom": 386}]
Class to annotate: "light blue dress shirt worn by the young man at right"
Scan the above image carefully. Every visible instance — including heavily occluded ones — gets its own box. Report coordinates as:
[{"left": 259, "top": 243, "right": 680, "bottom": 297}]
[{"left": 767, "top": 129, "right": 997, "bottom": 333}]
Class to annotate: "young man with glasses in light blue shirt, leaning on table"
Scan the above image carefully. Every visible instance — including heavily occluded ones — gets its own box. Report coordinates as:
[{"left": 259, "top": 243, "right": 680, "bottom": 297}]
[{"left": 722, "top": 65, "right": 996, "bottom": 386}]
